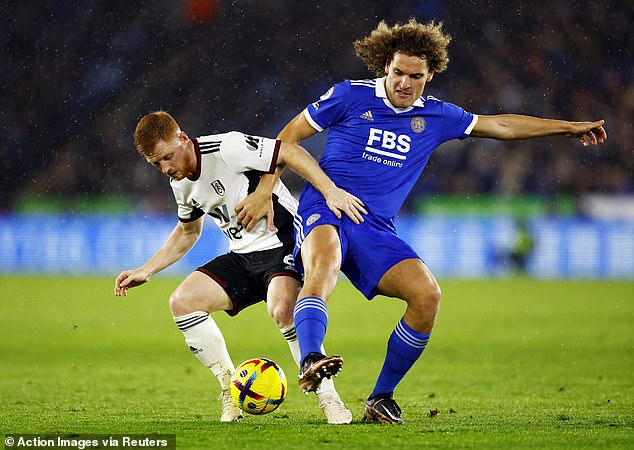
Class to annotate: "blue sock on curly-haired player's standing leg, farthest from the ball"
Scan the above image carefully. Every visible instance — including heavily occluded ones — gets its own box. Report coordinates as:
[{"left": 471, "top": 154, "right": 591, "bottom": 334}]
[{"left": 370, "top": 319, "right": 429, "bottom": 397}]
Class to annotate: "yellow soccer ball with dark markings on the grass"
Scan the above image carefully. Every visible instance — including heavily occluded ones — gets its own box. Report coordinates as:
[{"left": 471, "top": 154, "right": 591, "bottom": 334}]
[{"left": 230, "top": 358, "right": 288, "bottom": 414}]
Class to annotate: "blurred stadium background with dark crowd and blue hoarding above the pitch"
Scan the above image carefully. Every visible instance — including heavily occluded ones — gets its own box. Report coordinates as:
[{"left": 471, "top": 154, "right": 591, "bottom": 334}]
[{"left": 0, "top": 0, "right": 634, "bottom": 279}]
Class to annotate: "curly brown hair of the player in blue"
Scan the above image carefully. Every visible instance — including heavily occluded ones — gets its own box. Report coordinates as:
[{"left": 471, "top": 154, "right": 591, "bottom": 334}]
[{"left": 353, "top": 18, "right": 451, "bottom": 76}]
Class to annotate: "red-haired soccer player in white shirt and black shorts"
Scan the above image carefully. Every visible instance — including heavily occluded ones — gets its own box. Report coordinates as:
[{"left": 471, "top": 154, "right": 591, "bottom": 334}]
[{"left": 114, "top": 111, "right": 366, "bottom": 424}]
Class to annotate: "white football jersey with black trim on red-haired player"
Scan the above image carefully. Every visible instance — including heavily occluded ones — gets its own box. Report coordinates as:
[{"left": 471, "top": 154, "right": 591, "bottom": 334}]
[{"left": 170, "top": 131, "right": 297, "bottom": 253}]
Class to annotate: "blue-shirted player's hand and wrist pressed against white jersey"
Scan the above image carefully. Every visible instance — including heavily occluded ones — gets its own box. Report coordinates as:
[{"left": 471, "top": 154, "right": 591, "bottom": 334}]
[{"left": 235, "top": 166, "right": 284, "bottom": 231}]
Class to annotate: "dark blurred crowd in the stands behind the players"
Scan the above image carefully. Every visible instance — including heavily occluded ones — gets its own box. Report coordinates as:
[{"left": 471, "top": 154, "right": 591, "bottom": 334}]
[{"left": 0, "top": 0, "right": 634, "bottom": 211}]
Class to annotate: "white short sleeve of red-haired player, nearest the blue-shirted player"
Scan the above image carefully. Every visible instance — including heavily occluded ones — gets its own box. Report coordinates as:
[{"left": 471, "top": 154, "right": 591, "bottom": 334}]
[{"left": 220, "top": 131, "right": 281, "bottom": 173}]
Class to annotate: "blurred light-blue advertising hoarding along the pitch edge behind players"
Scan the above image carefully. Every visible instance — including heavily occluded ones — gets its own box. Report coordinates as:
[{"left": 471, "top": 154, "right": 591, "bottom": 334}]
[{"left": 0, "top": 215, "right": 634, "bottom": 279}]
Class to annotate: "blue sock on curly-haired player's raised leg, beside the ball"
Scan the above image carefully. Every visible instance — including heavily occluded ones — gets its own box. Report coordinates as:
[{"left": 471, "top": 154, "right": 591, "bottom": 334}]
[{"left": 293, "top": 297, "right": 328, "bottom": 363}]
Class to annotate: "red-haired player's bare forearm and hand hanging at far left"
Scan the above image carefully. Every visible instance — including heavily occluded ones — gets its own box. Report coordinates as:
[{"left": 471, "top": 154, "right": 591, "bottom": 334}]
[{"left": 114, "top": 217, "right": 203, "bottom": 297}]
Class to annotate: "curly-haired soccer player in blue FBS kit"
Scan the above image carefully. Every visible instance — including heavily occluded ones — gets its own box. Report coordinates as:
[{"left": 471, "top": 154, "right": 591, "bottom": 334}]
[{"left": 242, "top": 19, "right": 607, "bottom": 423}]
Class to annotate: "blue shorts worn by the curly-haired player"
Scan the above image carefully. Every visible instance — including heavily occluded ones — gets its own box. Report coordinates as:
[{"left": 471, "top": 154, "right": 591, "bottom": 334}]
[{"left": 293, "top": 198, "right": 420, "bottom": 300}]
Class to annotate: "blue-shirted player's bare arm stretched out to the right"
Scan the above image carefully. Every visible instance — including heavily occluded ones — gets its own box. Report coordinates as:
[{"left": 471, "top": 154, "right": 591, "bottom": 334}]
[{"left": 471, "top": 114, "right": 608, "bottom": 147}]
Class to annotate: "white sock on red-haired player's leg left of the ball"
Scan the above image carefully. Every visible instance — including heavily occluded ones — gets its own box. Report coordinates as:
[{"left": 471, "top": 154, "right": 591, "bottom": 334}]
[{"left": 174, "top": 311, "right": 235, "bottom": 389}]
